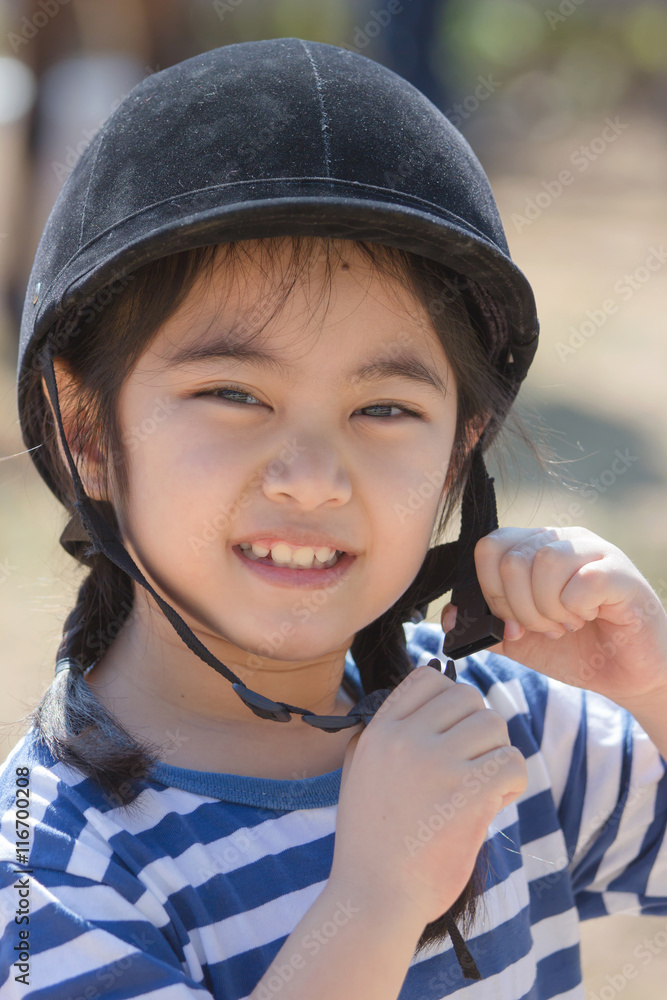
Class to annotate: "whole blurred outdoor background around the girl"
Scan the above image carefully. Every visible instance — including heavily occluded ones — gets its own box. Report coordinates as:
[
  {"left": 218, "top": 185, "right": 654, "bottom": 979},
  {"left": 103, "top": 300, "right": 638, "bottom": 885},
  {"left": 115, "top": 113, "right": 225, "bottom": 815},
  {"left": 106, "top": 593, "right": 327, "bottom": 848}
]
[{"left": 0, "top": 0, "right": 667, "bottom": 1000}]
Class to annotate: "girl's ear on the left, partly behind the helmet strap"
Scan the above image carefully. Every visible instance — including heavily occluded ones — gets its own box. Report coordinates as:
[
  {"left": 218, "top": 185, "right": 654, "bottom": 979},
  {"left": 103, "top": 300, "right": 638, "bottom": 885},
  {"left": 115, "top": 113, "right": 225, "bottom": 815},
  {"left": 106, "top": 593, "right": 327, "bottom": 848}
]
[{"left": 42, "top": 358, "right": 108, "bottom": 500}]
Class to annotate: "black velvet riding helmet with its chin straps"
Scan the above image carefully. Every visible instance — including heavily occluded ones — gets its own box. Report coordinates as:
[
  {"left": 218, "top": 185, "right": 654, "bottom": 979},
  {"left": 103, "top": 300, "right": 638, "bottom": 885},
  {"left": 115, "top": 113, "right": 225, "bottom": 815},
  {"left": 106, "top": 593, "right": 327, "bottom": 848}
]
[{"left": 18, "top": 38, "right": 539, "bottom": 978}]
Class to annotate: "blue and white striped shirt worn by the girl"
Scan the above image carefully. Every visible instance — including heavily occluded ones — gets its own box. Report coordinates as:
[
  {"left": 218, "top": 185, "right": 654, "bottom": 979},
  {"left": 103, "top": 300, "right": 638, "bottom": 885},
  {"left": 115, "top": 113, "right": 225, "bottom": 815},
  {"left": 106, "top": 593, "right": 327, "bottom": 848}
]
[{"left": 0, "top": 622, "right": 667, "bottom": 1000}]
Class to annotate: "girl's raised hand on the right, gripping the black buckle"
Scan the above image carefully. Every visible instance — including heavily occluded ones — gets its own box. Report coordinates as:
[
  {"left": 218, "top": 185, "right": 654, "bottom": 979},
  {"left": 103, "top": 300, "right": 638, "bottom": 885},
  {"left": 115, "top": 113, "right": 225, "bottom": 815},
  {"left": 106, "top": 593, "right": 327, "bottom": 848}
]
[{"left": 442, "top": 527, "right": 667, "bottom": 709}]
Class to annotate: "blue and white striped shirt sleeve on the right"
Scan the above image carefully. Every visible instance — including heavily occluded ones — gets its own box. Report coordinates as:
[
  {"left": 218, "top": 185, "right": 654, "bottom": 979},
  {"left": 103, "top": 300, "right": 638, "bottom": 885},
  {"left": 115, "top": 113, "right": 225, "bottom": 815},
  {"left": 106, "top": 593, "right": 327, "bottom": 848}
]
[{"left": 541, "top": 679, "right": 667, "bottom": 920}]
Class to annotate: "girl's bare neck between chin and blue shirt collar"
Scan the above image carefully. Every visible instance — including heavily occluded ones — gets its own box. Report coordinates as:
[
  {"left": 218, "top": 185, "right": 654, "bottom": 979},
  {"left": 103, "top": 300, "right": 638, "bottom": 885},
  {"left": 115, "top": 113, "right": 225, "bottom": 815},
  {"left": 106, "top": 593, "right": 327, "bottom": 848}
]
[{"left": 86, "top": 596, "right": 360, "bottom": 779}]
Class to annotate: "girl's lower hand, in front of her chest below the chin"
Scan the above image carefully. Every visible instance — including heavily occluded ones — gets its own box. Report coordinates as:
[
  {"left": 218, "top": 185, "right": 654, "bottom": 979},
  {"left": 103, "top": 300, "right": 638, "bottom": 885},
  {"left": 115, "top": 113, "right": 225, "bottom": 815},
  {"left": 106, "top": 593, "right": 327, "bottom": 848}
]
[{"left": 329, "top": 667, "right": 527, "bottom": 924}]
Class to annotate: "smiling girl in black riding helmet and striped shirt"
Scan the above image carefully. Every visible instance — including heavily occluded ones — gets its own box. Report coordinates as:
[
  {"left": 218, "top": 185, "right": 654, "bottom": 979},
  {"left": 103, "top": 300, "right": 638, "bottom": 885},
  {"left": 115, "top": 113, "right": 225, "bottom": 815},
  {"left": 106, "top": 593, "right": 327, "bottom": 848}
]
[{"left": 0, "top": 38, "right": 667, "bottom": 1000}]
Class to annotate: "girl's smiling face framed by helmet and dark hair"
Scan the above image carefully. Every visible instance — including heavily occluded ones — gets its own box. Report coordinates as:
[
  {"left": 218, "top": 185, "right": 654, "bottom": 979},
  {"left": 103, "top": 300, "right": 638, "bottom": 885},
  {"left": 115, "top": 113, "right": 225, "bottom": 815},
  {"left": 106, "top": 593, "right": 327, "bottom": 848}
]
[{"left": 108, "top": 241, "right": 457, "bottom": 697}]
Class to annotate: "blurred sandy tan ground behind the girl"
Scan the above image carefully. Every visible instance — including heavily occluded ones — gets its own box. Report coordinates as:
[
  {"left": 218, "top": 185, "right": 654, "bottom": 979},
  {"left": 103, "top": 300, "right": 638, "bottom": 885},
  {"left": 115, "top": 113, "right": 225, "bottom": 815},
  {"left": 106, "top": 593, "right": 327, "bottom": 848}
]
[{"left": 0, "top": 114, "right": 667, "bottom": 1000}]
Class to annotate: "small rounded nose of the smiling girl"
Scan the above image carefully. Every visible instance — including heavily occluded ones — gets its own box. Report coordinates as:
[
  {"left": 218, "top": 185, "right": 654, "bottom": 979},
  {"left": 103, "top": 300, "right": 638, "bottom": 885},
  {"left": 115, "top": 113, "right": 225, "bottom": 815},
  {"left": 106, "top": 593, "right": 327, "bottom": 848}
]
[{"left": 263, "top": 434, "right": 352, "bottom": 509}]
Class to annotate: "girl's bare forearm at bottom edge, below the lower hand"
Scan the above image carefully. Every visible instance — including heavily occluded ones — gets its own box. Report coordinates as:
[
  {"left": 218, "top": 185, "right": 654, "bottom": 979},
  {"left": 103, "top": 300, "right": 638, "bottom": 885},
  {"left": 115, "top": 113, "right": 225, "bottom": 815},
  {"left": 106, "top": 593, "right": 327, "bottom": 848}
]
[{"left": 249, "top": 882, "right": 425, "bottom": 1000}]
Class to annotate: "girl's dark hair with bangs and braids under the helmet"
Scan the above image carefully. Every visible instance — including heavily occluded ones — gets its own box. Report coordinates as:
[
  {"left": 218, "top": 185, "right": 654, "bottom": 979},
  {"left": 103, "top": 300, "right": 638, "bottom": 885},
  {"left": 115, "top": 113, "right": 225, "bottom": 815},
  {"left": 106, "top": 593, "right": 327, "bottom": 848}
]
[{"left": 20, "top": 236, "right": 551, "bottom": 951}]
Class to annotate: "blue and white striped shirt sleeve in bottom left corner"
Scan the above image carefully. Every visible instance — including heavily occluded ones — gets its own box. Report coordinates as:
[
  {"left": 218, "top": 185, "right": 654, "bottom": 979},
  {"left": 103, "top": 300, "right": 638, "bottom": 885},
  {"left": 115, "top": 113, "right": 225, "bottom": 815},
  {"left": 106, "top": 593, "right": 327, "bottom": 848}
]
[{"left": 0, "top": 862, "right": 212, "bottom": 1000}]
